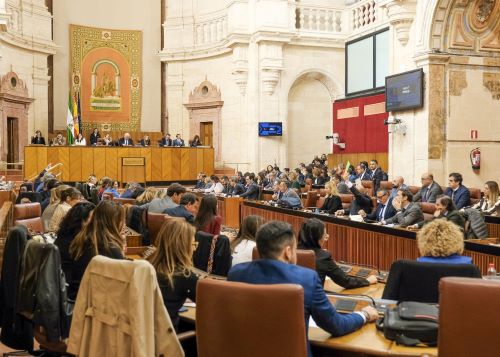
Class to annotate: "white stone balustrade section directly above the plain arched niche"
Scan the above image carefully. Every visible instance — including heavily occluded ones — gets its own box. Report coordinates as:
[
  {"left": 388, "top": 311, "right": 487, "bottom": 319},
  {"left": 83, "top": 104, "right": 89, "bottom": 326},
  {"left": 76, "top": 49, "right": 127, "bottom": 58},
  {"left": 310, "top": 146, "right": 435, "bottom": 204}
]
[{"left": 295, "top": 4, "right": 345, "bottom": 34}]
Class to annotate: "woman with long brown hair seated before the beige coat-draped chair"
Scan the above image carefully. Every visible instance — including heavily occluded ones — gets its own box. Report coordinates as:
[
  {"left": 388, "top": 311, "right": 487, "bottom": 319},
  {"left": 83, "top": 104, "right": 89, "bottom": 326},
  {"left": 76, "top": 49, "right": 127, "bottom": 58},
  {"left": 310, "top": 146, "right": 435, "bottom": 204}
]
[{"left": 68, "top": 200, "right": 125, "bottom": 300}]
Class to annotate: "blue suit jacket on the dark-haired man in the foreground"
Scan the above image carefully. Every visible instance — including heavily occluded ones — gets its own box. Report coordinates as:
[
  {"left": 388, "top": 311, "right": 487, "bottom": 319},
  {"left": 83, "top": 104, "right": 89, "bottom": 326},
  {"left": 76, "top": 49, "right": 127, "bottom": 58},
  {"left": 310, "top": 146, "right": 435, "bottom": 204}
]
[{"left": 227, "top": 259, "right": 364, "bottom": 356}]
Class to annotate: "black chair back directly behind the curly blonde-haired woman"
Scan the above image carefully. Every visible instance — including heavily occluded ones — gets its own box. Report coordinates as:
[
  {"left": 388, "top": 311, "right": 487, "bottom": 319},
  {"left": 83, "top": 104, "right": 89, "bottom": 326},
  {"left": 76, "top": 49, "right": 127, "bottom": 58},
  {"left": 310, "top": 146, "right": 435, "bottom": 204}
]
[{"left": 382, "top": 260, "right": 481, "bottom": 304}]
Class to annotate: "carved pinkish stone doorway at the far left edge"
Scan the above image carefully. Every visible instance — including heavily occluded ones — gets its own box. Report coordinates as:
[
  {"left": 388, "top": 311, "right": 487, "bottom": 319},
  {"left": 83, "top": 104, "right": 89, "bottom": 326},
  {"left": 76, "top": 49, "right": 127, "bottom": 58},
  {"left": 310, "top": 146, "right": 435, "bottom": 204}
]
[{"left": 0, "top": 72, "right": 33, "bottom": 162}]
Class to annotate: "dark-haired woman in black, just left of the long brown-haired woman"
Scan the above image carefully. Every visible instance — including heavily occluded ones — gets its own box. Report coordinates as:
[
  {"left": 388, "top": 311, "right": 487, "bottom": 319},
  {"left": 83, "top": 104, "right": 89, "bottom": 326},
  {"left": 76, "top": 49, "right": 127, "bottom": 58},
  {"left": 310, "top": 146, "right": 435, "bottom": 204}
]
[{"left": 54, "top": 202, "right": 95, "bottom": 284}]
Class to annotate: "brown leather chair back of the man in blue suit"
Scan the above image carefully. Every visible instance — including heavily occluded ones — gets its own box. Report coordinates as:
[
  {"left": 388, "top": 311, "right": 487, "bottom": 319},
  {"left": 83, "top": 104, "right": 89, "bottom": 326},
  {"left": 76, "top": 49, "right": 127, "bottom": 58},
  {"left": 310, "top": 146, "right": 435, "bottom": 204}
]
[{"left": 196, "top": 279, "right": 307, "bottom": 357}]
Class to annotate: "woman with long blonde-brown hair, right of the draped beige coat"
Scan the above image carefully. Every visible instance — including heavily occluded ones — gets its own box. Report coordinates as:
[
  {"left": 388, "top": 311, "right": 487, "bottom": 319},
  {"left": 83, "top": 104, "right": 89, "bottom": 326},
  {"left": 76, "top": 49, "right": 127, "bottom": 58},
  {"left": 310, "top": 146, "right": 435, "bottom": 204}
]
[{"left": 148, "top": 218, "right": 198, "bottom": 330}]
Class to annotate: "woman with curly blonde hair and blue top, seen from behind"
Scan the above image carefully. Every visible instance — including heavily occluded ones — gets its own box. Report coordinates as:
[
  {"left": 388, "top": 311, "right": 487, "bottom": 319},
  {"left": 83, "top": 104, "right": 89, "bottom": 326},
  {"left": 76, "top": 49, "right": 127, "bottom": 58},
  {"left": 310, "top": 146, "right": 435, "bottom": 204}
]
[{"left": 417, "top": 219, "right": 472, "bottom": 264}]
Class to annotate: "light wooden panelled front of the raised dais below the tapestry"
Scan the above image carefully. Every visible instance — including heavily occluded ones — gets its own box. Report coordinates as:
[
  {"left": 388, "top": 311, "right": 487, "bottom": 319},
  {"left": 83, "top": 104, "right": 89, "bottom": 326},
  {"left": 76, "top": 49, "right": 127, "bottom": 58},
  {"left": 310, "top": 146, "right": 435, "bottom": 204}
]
[{"left": 24, "top": 146, "right": 214, "bottom": 182}]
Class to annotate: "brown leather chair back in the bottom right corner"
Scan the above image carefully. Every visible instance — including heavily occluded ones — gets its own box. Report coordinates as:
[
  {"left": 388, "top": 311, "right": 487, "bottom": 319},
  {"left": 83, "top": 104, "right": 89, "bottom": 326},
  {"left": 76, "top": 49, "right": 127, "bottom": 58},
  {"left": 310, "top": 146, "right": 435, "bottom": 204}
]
[{"left": 438, "top": 278, "right": 500, "bottom": 357}]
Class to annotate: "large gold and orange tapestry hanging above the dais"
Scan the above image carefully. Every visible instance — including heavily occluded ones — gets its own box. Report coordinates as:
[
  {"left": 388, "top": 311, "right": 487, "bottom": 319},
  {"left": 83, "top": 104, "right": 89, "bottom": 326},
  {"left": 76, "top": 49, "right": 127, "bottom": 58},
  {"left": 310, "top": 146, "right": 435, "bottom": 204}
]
[{"left": 70, "top": 25, "right": 142, "bottom": 131}]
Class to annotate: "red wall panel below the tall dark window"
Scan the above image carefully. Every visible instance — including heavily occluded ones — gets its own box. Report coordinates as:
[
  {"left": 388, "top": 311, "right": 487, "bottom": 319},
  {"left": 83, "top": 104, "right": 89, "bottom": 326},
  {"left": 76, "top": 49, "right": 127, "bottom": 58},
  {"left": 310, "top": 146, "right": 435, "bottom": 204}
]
[{"left": 333, "top": 94, "right": 389, "bottom": 154}]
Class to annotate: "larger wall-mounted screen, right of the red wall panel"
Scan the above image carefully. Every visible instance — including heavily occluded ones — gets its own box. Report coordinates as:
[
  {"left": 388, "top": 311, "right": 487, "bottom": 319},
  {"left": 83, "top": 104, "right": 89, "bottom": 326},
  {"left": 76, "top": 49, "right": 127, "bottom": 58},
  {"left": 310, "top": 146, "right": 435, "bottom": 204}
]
[{"left": 385, "top": 68, "right": 424, "bottom": 112}]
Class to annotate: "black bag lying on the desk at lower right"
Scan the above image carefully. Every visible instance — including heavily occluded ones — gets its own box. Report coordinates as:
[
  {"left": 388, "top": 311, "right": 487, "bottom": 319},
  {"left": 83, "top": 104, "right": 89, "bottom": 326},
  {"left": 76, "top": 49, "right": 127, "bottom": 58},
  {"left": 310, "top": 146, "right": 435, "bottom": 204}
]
[{"left": 376, "top": 301, "right": 439, "bottom": 346}]
